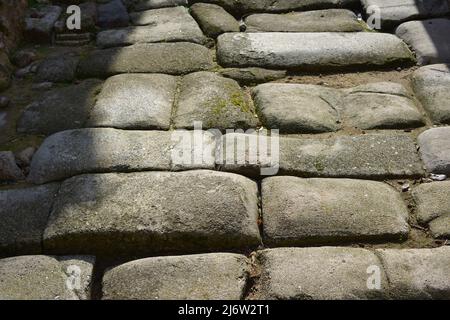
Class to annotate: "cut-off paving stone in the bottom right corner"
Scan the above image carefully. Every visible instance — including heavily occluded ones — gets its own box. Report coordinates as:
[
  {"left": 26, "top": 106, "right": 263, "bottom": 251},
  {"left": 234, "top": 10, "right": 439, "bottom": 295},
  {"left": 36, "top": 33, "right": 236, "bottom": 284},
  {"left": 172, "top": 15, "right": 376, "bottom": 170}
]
[{"left": 376, "top": 247, "right": 450, "bottom": 300}]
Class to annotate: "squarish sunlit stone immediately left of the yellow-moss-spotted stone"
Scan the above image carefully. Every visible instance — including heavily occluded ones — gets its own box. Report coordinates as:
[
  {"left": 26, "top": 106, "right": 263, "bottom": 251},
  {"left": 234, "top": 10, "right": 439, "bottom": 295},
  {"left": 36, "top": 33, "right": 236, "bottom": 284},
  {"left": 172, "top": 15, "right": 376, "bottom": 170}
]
[{"left": 88, "top": 74, "right": 177, "bottom": 130}]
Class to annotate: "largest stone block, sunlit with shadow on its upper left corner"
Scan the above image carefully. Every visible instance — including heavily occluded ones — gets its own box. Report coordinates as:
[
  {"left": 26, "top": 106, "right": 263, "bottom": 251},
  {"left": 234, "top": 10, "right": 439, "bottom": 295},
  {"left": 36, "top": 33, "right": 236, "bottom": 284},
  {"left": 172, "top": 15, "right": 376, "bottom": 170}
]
[{"left": 44, "top": 171, "right": 260, "bottom": 256}]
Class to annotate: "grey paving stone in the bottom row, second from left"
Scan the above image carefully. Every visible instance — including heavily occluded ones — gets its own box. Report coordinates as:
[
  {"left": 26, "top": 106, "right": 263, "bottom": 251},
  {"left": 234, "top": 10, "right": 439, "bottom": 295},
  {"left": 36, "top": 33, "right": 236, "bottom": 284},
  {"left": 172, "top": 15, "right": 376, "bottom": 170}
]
[{"left": 103, "top": 253, "right": 249, "bottom": 300}]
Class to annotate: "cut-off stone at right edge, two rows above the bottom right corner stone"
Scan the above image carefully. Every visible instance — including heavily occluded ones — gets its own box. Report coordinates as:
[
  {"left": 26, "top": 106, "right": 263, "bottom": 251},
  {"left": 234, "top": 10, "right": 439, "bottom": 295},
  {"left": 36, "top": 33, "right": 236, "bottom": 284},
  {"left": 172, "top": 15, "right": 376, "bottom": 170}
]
[{"left": 413, "top": 181, "right": 450, "bottom": 238}]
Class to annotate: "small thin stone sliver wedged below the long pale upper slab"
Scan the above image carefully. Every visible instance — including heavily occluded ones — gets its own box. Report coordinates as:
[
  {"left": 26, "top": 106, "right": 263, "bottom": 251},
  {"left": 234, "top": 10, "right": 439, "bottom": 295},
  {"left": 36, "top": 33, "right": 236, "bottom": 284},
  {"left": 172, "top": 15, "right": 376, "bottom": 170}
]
[{"left": 219, "top": 68, "right": 286, "bottom": 85}]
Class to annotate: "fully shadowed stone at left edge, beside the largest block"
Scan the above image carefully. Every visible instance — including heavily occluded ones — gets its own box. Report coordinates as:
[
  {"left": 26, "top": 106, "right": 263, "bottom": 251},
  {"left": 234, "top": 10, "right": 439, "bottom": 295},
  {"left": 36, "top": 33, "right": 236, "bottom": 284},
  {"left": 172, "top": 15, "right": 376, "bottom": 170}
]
[{"left": 0, "top": 184, "right": 58, "bottom": 256}]
